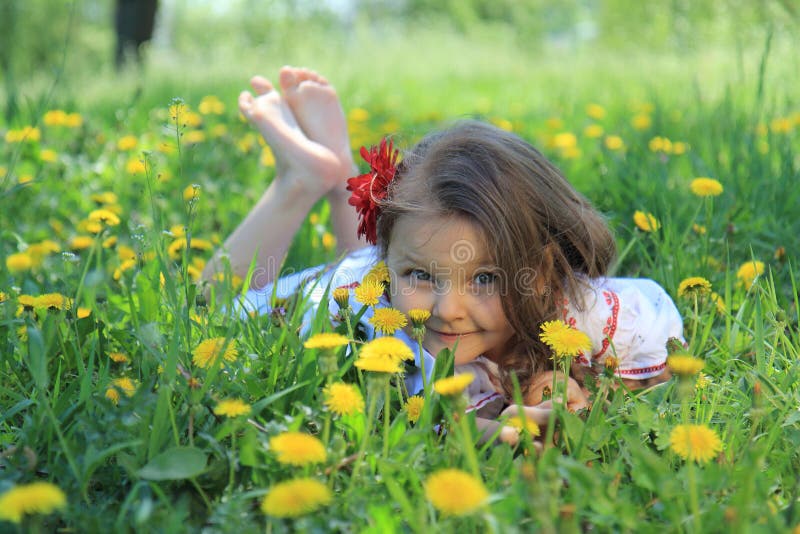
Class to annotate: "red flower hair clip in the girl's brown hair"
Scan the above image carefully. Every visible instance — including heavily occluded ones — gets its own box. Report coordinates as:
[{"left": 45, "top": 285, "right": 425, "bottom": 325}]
[{"left": 347, "top": 137, "right": 398, "bottom": 245}]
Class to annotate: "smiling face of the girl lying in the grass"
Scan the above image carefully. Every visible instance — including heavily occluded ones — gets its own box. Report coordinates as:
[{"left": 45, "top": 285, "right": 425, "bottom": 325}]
[{"left": 386, "top": 216, "right": 514, "bottom": 365}]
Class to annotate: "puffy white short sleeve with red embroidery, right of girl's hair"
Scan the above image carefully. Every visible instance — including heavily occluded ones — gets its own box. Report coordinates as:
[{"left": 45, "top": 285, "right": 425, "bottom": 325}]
[{"left": 565, "top": 278, "right": 683, "bottom": 380}]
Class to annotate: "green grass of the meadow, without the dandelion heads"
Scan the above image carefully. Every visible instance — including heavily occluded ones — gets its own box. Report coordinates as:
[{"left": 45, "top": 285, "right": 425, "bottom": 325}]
[{"left": 0, "top": 23, "right": 800, "bottom": 532}]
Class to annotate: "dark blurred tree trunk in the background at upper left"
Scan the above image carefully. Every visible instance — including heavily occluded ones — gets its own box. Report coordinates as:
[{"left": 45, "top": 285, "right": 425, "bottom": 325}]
[{"left": 114, "top": 0, "right": 158, "bottom": 69}]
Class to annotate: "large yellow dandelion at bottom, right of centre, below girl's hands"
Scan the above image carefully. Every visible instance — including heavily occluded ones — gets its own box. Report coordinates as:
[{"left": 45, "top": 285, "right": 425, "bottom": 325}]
[{"left": 425, "top": 469, "right": 489, "bottom": 516}]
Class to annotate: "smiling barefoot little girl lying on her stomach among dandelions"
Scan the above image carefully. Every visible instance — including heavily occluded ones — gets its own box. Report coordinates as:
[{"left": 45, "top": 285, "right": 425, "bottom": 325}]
[{"left": 204, "top": 67, "right": 682, "bottom": 442}]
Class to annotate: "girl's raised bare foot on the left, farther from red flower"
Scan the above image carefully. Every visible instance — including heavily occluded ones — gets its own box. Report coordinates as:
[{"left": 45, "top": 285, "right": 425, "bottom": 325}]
[{"left": 239, "top": 76, "right": 342, "bottom": 196}]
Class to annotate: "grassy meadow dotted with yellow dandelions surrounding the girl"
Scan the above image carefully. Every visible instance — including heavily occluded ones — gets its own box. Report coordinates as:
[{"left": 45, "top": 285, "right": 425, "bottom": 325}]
[{"left": 0, "top": 45, "right": 800, "bottom": 533}]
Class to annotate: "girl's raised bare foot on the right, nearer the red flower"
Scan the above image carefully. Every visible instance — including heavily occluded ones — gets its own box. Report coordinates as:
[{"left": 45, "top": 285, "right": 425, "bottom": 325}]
[{"left": 280, "top": 67, "right": 354, "bottom": 185}]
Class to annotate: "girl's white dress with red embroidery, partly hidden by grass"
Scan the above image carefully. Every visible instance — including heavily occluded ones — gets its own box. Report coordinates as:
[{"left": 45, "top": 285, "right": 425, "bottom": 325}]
[{"left": 241, "top": 246, "right": 683, "bottom": 410}]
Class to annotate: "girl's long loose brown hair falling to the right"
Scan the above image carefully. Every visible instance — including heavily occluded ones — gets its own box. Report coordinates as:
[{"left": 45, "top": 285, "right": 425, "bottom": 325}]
[{"left": 377, "top": 121, "right": 616, "bottom": 393}]
